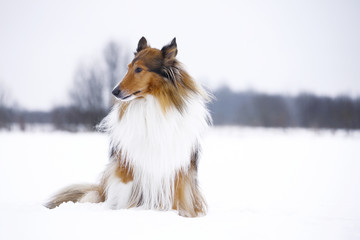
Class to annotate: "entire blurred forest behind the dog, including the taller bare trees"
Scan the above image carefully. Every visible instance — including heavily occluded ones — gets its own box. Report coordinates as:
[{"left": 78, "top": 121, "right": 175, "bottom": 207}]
[{"left": 0, "top": 42, "right": 360, "bottom": 131}]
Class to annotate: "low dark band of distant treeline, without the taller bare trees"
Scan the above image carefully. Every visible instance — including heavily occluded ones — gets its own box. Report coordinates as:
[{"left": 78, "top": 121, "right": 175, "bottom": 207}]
[{"left": 0, "top": 88, "right": 360, "bottom": 131}]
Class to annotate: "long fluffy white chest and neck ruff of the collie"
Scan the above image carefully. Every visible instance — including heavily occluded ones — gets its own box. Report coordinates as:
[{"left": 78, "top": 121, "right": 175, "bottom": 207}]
[{"left": 100, "top": 95, "right": 210, "bottom": 210}]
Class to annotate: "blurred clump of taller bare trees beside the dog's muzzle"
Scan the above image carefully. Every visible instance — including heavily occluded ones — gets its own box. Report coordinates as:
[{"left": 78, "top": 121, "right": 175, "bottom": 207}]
[{"left": 52, "top": 42, "right": 130, "bottom": 131}]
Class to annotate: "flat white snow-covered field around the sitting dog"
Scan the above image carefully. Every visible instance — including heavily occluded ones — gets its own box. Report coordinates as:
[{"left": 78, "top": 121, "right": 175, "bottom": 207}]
[{"left": 0, "top": 127, "right": 360, "bottom": 240}]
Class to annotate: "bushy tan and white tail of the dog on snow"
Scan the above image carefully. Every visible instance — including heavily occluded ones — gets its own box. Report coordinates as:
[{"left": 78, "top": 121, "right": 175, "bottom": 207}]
[{"left": 44, "top": 184, "right": 105, "bottom": 209}]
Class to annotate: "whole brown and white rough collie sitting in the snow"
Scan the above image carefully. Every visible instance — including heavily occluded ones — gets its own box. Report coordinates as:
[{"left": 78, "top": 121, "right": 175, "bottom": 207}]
[{"left": 46, "top": 37, "right": 211, "bottom": 217}]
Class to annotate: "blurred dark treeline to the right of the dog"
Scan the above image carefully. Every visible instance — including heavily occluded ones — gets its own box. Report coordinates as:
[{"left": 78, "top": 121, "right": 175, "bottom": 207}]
[{"left": 210, "top": 87, "right": 360, "bottom": 129}]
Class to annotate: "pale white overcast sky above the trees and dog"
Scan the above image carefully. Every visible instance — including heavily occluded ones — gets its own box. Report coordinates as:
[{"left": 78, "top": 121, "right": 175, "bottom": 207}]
[{"left": 0, "top": 0, "right": 360, "bottom": 110}]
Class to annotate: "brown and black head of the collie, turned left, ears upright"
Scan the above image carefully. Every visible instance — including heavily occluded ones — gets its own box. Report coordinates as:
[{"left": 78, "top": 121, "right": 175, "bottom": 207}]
[{"left": 112, "top": 37, "right": 179, "bottom": 101}]
